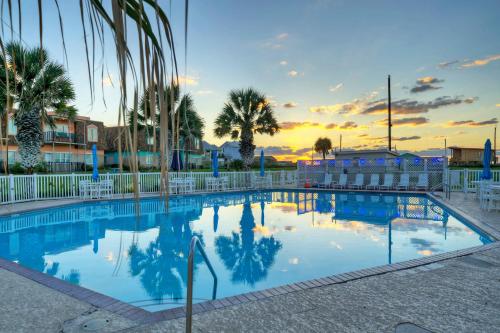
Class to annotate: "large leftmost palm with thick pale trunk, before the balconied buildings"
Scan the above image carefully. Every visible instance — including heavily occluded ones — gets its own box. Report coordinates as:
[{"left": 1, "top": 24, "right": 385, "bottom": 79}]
[{"left": 0, "top": 43, "right": 76, "bottom": 173}]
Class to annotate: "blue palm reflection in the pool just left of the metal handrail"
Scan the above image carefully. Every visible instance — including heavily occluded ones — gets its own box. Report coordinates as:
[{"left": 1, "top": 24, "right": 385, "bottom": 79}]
[{"left": 128, "top": 214, "right": 203, "bottom": 300}]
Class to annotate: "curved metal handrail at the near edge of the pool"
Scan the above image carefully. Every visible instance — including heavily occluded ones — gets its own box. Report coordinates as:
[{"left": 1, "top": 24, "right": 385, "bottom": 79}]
[{"left": 186, "top": 236, "right": 217, "bottom": 333}]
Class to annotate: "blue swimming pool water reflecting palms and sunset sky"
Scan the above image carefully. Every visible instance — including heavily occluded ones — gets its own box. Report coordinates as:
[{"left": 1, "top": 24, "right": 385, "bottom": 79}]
[{"left": 0, "top": 191, "right": 490, "bottom": 311}]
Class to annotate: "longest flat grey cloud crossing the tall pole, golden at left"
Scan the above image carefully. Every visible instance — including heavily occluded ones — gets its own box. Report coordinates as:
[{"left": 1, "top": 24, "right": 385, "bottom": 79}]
[{"left": 361, "top": 96, "right": 478, "bottom": 115}]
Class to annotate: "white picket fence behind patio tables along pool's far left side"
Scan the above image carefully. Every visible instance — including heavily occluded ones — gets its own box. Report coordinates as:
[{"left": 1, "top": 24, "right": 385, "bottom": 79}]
[{"left": 0, "top": 170, "right": 296, "bottom": 204}]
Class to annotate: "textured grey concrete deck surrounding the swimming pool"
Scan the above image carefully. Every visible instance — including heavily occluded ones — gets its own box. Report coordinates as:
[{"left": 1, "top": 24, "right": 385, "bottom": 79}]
[{"left": 0, "top": 193, "right": 500, "bottom": 332}]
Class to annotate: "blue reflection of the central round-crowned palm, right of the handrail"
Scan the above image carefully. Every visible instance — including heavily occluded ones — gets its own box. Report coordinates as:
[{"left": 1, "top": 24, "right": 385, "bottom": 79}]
[{"left": 215, "top": 197, "right": 282, "bottom": 286}]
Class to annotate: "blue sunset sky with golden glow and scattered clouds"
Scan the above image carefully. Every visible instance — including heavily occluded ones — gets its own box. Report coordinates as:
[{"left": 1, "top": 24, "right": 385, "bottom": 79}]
[{"left": 3, "top": 0, "right": 500, "bottom": 160}]
